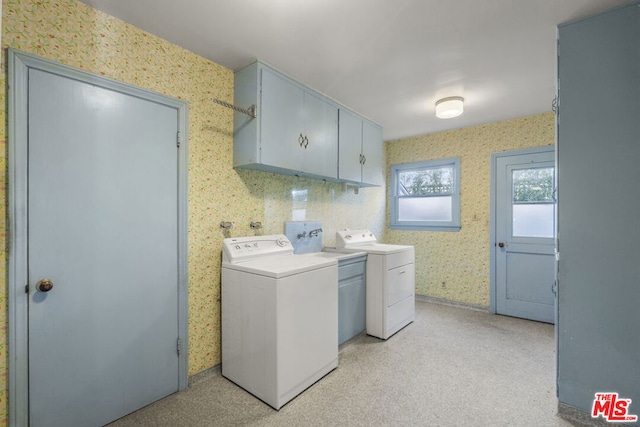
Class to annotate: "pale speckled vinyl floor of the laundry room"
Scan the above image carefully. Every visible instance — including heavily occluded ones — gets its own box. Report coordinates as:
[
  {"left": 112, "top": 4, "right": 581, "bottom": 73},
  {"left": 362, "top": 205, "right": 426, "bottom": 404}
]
[{"left": 110, "top": 301, "right": 571, "bottom": 427}]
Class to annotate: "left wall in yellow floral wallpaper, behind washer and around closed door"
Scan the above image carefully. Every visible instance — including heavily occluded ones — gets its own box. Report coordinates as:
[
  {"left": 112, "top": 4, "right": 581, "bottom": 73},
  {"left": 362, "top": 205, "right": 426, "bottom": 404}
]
[{"left": 0, "top": 0, "right": 385, "bottom": 426}]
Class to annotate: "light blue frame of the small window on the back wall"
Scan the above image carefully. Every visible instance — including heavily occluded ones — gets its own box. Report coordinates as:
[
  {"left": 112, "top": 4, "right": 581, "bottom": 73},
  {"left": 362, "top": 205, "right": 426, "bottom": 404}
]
[{"left": 389, "top": 157, "right": 461, "bottom": 231}]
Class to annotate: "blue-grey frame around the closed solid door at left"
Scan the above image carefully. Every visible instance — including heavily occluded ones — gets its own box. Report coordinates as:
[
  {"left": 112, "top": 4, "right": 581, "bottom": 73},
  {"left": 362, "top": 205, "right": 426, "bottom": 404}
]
[{"left": 7, "top": 49, "right": 188, "bottom": 426}]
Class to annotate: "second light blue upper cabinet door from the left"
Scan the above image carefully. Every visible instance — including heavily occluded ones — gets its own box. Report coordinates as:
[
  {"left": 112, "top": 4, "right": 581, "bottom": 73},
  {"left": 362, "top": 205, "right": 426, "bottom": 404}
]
[{"left": 300, "top": 92, "right": 338, "bottom": 178}]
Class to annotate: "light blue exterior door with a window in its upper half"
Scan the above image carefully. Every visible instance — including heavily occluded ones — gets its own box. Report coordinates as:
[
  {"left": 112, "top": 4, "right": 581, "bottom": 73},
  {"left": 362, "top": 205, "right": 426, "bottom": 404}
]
[{"left": 492, "top": 148, "right": 556, "bottom": 323}]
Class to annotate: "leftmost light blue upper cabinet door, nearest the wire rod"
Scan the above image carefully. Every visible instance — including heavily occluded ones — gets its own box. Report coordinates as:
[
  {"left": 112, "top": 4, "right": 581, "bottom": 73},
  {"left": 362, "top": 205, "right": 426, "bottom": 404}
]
[{"left": 260, "top": 68, "right": 304, "bottom": 170}]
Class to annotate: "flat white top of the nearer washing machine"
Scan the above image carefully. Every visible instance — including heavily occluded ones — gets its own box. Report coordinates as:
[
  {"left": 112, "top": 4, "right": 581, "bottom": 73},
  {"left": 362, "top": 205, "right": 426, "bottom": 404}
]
[{"left": 222, "top": 255, "right": 338, "bottom": 279}]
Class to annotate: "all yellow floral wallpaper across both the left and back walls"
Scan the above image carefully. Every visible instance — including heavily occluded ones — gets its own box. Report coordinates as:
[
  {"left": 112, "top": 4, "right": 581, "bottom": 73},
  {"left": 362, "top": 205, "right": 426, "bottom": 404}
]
[{"left": 0, "top": 0, "right": 554, "bottom": 425}]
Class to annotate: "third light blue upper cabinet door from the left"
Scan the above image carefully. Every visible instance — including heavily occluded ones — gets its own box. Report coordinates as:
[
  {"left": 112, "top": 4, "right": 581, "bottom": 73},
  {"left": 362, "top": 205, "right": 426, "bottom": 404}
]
[{"left": 338, "top": 109, "right": 362, "bottom": 182}]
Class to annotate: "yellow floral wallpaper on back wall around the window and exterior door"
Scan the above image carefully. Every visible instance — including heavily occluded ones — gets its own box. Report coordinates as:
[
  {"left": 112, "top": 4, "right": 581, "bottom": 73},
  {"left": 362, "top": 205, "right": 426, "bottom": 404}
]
[{"left": 384, "top": 113, "right": 555, "bottom": 307}]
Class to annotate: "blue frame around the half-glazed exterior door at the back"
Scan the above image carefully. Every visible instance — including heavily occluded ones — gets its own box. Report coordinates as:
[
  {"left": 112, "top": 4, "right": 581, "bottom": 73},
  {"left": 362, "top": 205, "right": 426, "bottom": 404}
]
[{"left": 489, "top": 145, "right": 557, "bottom": 319}]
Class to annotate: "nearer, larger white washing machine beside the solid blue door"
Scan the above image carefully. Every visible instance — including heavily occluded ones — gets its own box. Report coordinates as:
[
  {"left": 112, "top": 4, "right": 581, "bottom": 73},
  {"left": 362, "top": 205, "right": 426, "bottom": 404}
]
[{"left": 222, "top": 235, "right": 338, "bottom": 409}]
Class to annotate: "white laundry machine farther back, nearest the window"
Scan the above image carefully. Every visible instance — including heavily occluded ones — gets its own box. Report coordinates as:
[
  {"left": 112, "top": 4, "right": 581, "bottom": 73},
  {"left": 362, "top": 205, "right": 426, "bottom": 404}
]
[{"left": 335, "top": 230, "right": 415, "bottom": 339}]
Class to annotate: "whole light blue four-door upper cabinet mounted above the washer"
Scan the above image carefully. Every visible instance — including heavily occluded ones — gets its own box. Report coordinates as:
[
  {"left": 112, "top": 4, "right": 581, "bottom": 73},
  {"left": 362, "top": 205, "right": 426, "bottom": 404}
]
[{"left": 233, "top": 61, "right": 384, "bottom": 185}]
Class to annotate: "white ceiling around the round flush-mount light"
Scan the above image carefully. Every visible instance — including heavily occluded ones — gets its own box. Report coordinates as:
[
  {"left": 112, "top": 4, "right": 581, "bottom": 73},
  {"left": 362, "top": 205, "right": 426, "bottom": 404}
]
[{"left": 82, "top": 0, "right": 627, "bottom": 140}]
